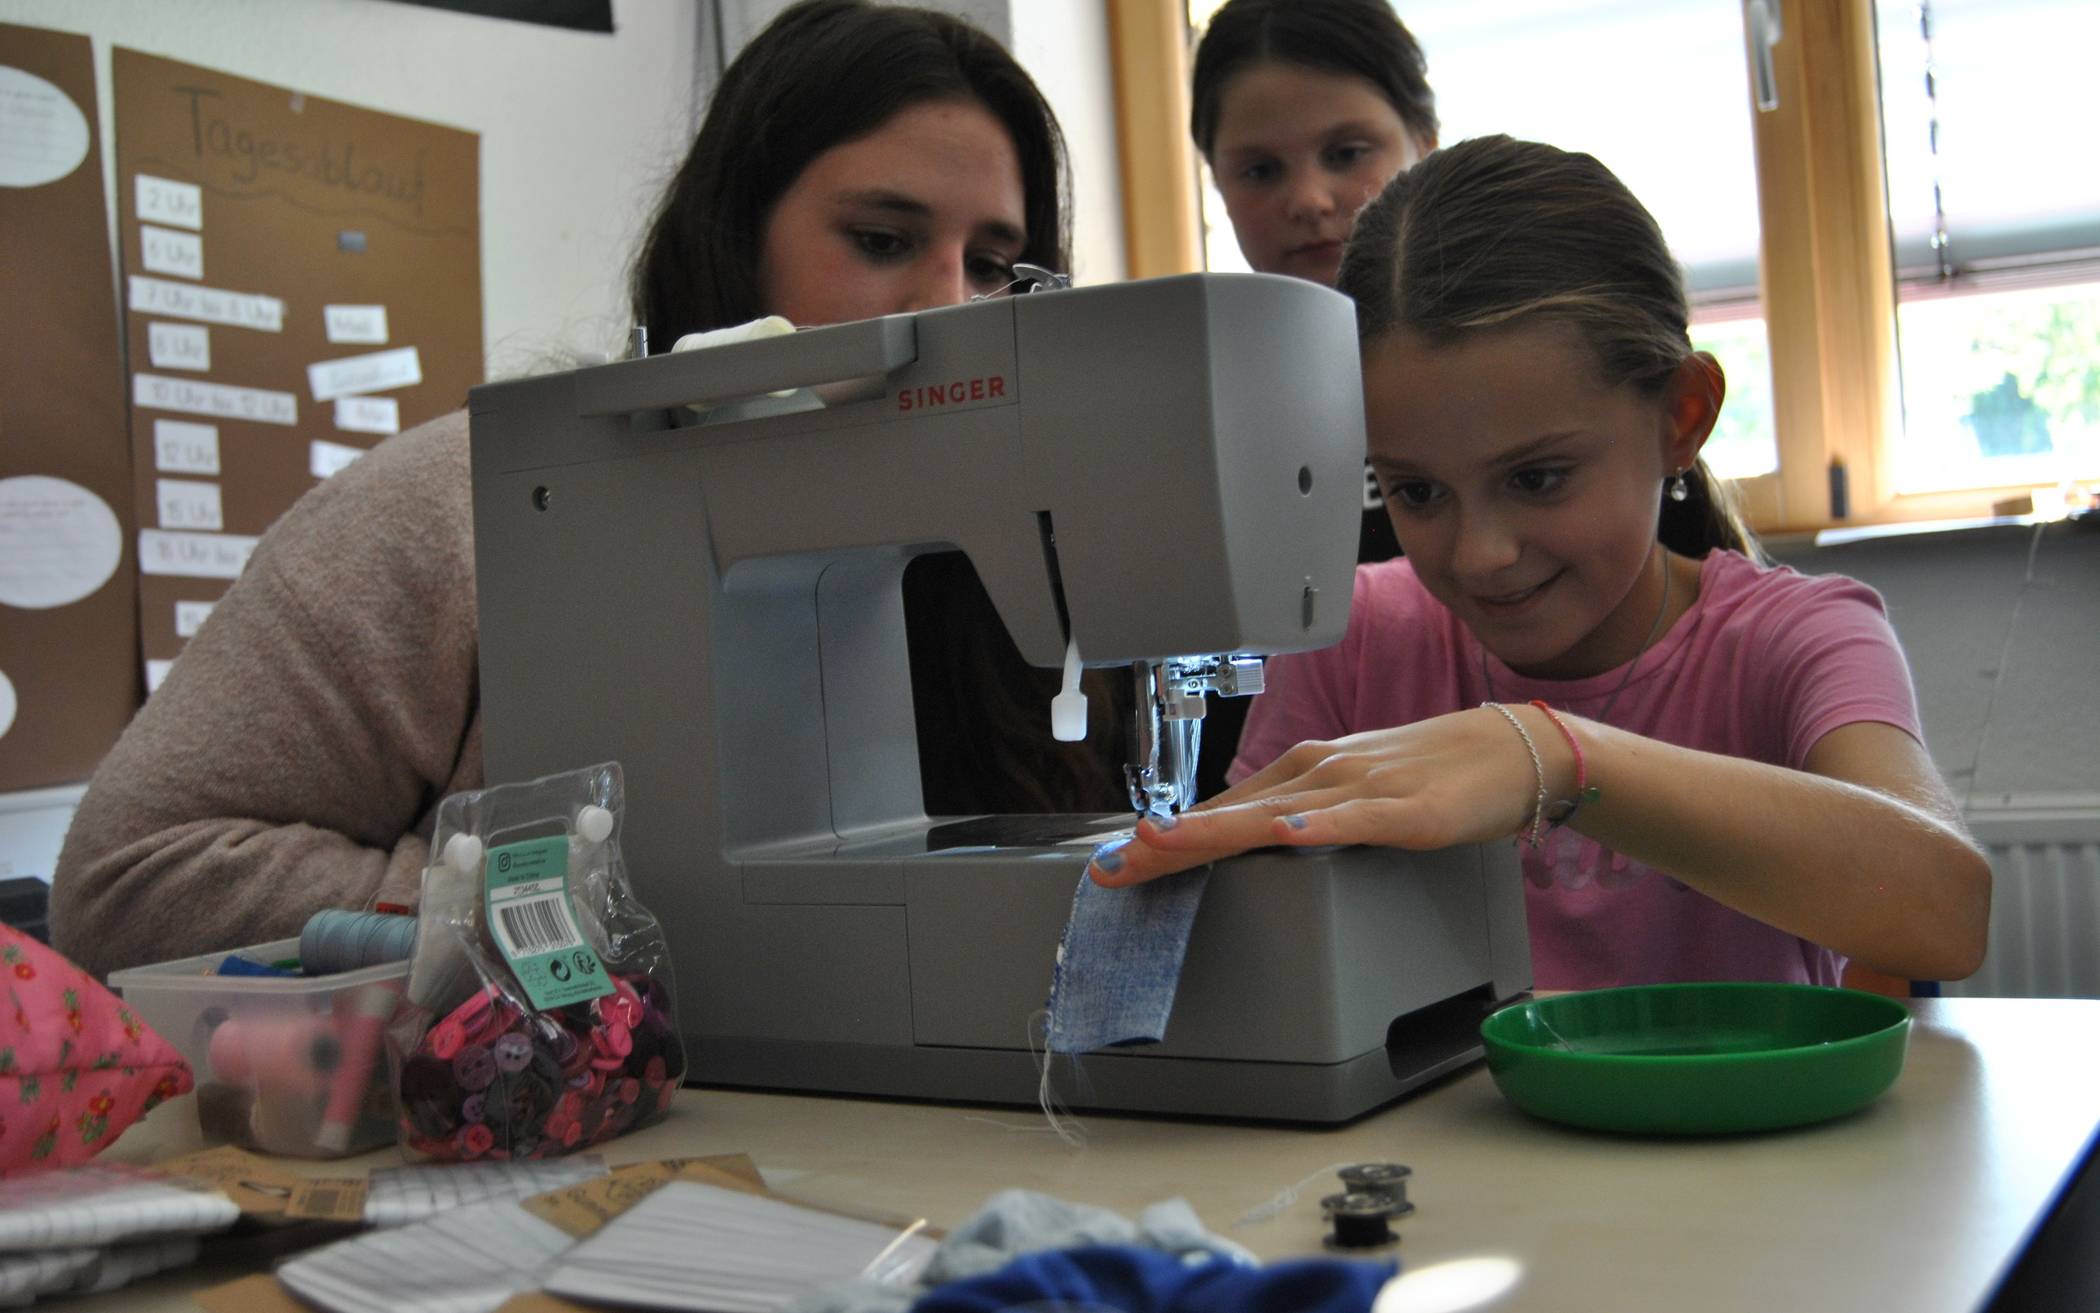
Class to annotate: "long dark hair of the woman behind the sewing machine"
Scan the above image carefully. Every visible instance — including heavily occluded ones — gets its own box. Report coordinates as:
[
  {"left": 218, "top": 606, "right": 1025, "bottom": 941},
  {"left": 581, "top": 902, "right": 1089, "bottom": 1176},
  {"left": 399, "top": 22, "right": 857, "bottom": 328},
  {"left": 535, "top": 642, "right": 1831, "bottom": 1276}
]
[{"left": 632, "top": 0, "right": 1071, "bottom": 351}]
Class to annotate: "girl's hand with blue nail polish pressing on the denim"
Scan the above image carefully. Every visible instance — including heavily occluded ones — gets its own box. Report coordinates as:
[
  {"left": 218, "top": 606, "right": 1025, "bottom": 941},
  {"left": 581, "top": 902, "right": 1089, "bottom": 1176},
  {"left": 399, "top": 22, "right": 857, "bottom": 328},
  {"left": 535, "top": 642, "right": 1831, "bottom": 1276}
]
[{"left": 1088, "top": 708, "right": 1573, "bottom": 887}]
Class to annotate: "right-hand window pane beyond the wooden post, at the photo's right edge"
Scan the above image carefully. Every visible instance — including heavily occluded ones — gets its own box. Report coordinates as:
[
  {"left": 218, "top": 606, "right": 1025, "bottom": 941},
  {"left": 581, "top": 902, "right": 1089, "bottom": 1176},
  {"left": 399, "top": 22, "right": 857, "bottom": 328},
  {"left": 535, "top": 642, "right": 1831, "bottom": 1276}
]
[{"left": 1877, "top": 0, "right": 2100, "bottom": 494}]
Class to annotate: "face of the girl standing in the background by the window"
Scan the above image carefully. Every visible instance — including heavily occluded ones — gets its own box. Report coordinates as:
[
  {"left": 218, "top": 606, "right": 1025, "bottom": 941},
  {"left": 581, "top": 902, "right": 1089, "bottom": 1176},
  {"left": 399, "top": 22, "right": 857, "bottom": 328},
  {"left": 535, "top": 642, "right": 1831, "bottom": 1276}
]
[{"left": 1210, "top": 61, "right": 1434, "bottom": 288}]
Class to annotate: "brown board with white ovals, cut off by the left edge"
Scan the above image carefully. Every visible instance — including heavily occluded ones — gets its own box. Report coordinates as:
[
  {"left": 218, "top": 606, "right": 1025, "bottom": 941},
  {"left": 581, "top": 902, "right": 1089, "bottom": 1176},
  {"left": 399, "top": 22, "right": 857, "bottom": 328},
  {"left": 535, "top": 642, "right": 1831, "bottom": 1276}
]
[{"left": 0, "top": 23, "right": 139, "bottom": 792}]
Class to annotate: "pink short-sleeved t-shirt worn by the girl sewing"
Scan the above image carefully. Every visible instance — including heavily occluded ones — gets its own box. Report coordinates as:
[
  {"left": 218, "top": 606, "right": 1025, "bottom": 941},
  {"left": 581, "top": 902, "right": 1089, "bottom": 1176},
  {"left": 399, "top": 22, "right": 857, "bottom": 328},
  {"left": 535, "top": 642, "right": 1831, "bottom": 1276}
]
[{"left": 1231, "top": 550, "right": 1924, "bottom": 989}]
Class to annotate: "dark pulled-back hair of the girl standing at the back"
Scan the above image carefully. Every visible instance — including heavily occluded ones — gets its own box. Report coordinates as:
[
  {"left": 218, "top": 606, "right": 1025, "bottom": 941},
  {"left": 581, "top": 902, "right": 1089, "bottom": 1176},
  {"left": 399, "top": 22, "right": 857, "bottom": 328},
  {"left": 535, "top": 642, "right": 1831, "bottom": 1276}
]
[{"left": 1189, "top": 0, "right": 1436, "bottom": 160}]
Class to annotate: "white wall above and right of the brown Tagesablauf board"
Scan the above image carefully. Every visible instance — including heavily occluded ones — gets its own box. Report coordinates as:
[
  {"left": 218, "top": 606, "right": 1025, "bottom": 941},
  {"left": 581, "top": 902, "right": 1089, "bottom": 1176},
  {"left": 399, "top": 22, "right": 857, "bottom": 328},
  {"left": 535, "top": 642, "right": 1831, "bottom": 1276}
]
[{"left": 0, "top": 0, "right": 712, "bottom": 376}]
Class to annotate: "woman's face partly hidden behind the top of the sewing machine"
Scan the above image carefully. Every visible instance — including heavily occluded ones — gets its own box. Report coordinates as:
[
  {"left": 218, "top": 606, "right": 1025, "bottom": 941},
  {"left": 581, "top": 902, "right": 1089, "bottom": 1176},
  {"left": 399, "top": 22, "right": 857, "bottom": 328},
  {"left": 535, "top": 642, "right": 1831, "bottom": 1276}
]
[{"left": 758, "top": 101, "right": 1027, "bottom": 326}]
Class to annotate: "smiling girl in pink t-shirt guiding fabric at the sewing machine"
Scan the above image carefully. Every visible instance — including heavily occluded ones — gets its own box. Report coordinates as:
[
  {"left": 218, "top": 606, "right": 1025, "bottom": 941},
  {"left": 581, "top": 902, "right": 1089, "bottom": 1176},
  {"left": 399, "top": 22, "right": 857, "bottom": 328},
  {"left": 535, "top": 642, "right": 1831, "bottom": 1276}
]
[{"left": 1090, "top": 137, "right": 1991, "bottom": 987}]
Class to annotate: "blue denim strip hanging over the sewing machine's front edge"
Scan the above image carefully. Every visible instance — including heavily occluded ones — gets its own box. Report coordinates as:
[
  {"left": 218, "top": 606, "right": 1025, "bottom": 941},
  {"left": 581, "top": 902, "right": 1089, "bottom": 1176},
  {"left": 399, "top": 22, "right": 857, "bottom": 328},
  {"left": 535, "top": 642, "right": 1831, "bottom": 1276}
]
[{"left": 1044, "top": 868, "right": 1210, "bottom": 1053}]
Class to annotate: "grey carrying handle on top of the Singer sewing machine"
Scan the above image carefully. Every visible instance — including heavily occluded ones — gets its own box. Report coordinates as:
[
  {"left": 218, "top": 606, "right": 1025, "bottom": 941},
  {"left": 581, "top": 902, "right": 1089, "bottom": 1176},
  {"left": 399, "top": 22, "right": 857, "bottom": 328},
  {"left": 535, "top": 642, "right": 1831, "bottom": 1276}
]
[{"left": 575, "top": 315, "right": 918, "bottom": 416}]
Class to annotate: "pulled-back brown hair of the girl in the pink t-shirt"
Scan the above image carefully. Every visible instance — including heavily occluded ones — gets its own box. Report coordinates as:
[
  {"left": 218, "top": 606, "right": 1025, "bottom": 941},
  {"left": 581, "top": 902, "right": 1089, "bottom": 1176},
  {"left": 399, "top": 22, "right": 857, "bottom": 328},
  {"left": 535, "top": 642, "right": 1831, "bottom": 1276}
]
[{"left": 1338, "top": 137, "right": 1762, "bottom": 557}]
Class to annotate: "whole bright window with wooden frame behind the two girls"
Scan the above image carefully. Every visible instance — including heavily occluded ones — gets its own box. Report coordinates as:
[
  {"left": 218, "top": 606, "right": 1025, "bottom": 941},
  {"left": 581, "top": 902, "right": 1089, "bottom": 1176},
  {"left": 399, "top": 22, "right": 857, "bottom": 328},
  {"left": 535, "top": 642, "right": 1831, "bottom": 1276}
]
[{"left": 1134, "top": 0, "right": 2100, "bottom": 529}]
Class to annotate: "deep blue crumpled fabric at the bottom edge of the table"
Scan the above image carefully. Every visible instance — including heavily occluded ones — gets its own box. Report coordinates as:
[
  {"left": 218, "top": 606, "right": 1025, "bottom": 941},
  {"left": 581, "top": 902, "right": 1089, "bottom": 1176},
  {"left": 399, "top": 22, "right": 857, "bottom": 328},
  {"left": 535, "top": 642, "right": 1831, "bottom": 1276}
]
[{"left": 911, "top": 1246, "right": 1399, "bottom": 1313}]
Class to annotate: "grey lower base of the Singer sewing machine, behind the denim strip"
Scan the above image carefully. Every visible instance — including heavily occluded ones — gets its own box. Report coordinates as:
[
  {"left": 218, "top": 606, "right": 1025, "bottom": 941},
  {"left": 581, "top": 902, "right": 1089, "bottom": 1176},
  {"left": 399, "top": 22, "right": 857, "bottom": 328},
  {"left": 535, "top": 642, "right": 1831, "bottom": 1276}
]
[{"left": 666, "top": 817, "right": 1531, "bottom": 1122}]
